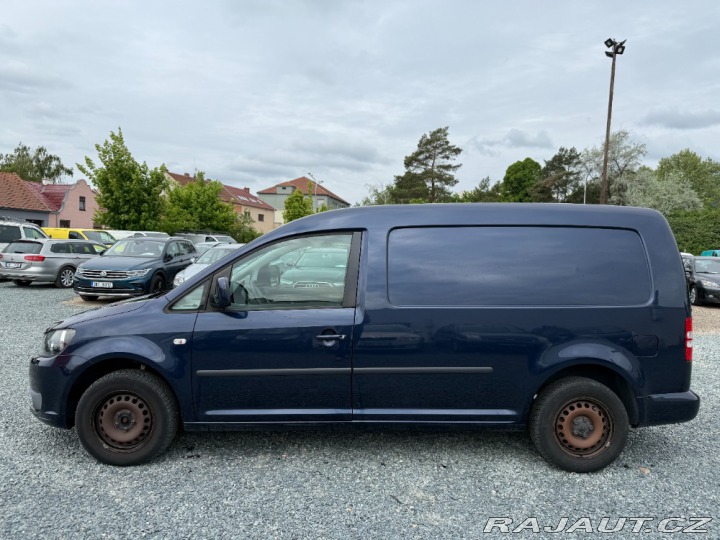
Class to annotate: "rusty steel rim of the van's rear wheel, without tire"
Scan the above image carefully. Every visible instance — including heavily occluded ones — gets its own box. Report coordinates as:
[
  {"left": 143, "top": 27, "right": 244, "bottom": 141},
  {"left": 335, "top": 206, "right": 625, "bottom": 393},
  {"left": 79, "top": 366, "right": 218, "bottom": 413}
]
[{"left": 555, "top": 399, "right": 613, "bottom": 457}]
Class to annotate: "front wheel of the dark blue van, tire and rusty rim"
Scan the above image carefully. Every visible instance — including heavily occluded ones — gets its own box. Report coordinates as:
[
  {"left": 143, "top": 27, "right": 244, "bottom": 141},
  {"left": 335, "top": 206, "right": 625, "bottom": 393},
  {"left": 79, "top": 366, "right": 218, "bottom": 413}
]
[{"left": 75, "top": 369, "right": 178, "bottom": 466}]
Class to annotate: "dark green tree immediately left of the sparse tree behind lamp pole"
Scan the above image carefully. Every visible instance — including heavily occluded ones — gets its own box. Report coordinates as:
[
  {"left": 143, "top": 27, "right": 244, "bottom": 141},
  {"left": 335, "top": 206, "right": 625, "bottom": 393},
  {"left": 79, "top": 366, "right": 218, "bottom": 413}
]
[{"left": 530, "top": 146, "right": 583, "bottom": 202}]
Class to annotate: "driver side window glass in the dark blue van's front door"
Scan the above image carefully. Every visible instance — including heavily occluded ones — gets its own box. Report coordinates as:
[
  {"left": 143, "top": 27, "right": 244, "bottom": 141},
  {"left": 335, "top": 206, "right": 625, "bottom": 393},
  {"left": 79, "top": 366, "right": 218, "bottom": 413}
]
[{"left": 229, "top": 233, "right": 352, "bottom": 310}]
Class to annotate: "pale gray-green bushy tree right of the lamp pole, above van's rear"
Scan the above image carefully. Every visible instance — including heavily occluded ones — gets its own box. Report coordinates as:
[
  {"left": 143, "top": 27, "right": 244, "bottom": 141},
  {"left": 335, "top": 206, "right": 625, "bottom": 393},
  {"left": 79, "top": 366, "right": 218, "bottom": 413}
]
[{"left": 616, "top": 167, "right": 703, "bottom": 216}]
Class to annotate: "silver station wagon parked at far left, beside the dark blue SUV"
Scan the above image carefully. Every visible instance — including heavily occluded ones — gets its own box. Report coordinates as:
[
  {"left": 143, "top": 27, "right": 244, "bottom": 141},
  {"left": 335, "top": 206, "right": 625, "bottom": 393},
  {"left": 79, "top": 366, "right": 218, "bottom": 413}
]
[{"left": 0, "top": 239, "right": 107, "bottom": 288}]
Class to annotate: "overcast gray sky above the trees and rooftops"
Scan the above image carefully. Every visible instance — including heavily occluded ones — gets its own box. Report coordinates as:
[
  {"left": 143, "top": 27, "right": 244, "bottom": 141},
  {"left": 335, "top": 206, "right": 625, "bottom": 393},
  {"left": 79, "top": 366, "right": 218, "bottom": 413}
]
[{"left": 0, "top": 0, "right": 720, "bottom": 203}]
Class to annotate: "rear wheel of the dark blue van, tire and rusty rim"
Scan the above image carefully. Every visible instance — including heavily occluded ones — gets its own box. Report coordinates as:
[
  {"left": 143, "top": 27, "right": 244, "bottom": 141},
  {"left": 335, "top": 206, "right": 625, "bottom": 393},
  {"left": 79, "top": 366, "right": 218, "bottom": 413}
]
[{"left": 529, "top": 377, "right": 629, "bottom": 472}]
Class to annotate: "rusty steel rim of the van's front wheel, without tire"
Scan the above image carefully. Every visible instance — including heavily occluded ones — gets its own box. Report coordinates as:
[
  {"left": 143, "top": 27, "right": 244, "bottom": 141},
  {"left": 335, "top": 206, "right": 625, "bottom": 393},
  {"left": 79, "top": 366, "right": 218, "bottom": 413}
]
[{"left": 95, "top": 392, "right": 153, "bottom": 450}]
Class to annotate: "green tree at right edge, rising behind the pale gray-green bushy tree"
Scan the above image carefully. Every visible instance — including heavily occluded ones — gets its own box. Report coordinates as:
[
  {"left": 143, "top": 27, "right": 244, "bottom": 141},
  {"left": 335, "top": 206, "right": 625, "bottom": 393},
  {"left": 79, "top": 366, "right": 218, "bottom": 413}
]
[{"left": 657, "top": 149, "right": 720, "bottom": 206}]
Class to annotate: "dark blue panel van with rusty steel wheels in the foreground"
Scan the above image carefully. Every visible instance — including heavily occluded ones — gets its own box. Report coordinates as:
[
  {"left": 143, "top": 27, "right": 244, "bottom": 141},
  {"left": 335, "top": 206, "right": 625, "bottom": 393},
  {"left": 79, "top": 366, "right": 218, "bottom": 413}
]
[{"left": 30, "top": 204, "right": 699, "bottom": 472}]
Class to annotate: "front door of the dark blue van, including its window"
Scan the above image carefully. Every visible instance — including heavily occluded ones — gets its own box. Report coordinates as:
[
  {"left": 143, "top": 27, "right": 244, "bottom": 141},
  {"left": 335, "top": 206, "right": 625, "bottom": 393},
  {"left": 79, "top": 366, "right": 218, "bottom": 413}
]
[{"left": 192, "top": 233, "right": 360, "bottom": 423}]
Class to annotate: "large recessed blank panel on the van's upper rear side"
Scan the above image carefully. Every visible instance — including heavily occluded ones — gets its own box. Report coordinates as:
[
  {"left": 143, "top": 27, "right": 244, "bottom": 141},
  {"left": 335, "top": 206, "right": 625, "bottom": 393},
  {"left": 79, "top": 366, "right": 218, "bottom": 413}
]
[{"left": 388, "top": 226, "right": 651, "bottom": 306}]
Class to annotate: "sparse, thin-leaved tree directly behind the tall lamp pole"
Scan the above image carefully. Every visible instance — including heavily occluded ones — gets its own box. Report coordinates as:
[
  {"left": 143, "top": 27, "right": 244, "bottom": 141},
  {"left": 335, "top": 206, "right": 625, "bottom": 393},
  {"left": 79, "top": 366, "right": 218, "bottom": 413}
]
[{"left": 581, "top": 130, "right": 647, "bottom": 202}]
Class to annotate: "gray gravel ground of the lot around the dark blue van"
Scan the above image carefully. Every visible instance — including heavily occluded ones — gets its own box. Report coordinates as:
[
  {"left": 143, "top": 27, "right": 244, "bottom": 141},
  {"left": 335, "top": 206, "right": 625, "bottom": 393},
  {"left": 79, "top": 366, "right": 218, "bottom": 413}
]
[{"left": 0, "top": 283, "right": 720, "bottom": 539}]
